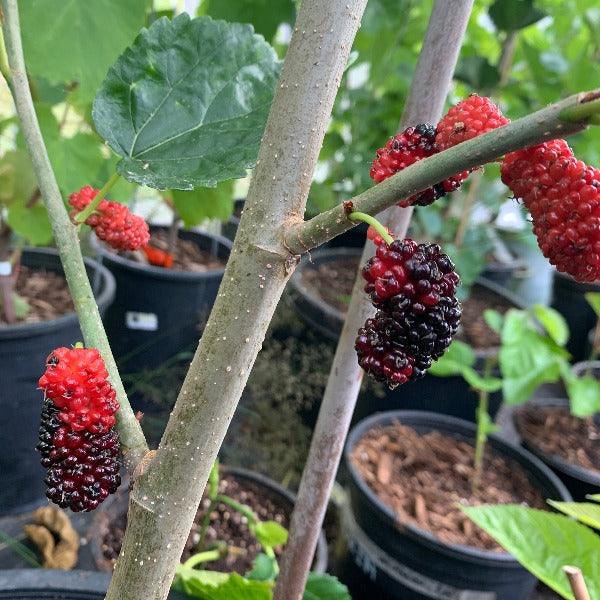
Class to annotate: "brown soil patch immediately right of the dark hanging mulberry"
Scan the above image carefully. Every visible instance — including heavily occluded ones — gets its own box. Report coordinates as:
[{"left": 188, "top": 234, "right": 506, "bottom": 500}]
[{"left": 456, "top": 285, "right": 515, "bottom": 350}]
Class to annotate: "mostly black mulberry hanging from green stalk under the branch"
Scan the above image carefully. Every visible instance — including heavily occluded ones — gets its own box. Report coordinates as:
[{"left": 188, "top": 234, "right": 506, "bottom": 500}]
[{"left": 355, "top": 237, "right": 461, "bottom": 388}]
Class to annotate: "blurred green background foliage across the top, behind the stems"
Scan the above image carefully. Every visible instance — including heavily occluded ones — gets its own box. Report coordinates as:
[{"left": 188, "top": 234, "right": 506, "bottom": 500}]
[{"left": 0, "top": 0, "right": 600, "bottom": 283}]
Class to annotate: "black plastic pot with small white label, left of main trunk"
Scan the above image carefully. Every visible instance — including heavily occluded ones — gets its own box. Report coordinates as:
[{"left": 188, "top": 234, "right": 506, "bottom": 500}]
[{"left": 91, "top": 227, "right": 232, "bottom": 373}]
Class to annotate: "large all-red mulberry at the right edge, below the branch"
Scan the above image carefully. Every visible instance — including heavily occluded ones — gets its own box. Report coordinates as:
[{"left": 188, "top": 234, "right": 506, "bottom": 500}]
[{"left": 501, "top": 140, "right": 600, "bottom": 282}]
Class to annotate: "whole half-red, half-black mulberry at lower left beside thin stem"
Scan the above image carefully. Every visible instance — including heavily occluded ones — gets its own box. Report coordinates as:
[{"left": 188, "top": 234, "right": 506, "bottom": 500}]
[{"left": 37, "top": 348, "right": 121, "bottom": 512}]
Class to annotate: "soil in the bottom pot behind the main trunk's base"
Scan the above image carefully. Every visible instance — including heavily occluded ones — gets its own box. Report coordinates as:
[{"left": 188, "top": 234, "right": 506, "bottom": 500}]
[{"left": 102, "top": 474, "right": 290, "bottom": 575}]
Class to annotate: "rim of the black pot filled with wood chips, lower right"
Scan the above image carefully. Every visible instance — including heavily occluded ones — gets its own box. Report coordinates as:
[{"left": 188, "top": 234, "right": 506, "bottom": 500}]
[{"left": 344, "top": 410, "right": 571, "bottom": 567}]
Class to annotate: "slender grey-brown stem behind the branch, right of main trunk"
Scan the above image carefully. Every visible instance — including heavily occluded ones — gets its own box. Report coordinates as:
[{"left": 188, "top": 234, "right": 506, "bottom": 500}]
[{"left": 274, "top": 0, "right": 472, "bottom": 600}]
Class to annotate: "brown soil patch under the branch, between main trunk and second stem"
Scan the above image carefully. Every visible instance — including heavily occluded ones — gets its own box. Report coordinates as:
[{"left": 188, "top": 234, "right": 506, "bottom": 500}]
[{"left": 302, "top": 256, "right": 359, "bottom": 313}]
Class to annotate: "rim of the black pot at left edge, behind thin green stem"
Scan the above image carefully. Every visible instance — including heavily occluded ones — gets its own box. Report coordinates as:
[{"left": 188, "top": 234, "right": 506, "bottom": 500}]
[{"left": 0, "top": 247, "right": 117, "bottom": 341}]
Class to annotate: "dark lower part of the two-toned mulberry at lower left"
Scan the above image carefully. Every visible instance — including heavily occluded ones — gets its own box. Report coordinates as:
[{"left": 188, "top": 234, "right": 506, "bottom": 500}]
[{"left": 37, "top": 399, "right": 121, "bottom": 512}]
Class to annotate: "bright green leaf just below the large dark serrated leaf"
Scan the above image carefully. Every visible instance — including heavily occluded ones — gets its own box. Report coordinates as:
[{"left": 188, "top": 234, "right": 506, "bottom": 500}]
[{"left": 170, "top": 179, "right": 234, "bottom": 227}]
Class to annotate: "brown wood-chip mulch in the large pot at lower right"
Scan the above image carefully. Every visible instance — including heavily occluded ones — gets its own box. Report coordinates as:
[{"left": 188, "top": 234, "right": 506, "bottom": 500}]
[{"left": 351, "top": 421, "right": 546, "bottom": 552}]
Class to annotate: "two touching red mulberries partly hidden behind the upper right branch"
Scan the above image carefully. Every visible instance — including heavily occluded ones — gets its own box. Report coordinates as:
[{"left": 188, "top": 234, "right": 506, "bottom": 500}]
[{"left": 371, "top": 95, "right": 508, "bottom": 207}]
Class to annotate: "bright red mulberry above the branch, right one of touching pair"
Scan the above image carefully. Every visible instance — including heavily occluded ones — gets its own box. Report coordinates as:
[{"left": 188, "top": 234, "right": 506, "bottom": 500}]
[{"left": 435, "top": 94, "right": 509, "bottom": 151}]
